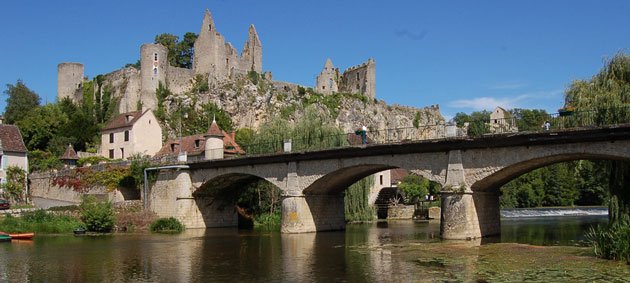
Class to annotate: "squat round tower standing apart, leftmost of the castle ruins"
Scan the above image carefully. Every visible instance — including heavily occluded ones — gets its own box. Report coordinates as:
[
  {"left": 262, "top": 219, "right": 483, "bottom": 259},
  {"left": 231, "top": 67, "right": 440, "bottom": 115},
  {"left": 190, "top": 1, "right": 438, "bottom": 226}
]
[{"left": 57, "top": 63, "right": 83, "bottom": 102}]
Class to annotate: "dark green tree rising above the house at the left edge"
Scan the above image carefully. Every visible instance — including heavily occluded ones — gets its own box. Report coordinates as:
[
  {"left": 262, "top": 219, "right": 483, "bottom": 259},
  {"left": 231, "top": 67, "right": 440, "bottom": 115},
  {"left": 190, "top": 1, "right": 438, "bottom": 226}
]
[{"left": 4, "top": 80, "right": 40, "bottom": 124}]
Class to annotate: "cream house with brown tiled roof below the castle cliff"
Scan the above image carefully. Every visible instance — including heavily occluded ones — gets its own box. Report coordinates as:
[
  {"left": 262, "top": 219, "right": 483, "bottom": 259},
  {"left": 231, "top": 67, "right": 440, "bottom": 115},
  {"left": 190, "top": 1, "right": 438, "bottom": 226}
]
[{"left": 101, "top": 109, "right": 162, "bottom": 159}]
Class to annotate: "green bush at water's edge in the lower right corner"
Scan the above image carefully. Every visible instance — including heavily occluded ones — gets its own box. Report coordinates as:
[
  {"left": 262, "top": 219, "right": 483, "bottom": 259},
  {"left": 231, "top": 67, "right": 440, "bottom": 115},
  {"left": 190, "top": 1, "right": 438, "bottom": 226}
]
[{"left": 586, "top": 220, "right": 630, "bottom": 264}]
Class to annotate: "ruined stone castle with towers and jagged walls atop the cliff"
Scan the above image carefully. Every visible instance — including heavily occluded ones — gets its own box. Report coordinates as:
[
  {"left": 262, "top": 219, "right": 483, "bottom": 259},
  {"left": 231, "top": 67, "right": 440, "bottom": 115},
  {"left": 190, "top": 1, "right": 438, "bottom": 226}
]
[{"left": 57, "top": 10, "right": 376, "bottom": 113}]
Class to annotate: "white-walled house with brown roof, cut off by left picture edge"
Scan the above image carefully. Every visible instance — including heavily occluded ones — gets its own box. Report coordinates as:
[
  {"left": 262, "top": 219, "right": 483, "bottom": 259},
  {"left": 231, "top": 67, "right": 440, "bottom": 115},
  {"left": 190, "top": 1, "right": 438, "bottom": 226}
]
[{"left": 0, "top": 124, "right": 28, "bottom": 183}]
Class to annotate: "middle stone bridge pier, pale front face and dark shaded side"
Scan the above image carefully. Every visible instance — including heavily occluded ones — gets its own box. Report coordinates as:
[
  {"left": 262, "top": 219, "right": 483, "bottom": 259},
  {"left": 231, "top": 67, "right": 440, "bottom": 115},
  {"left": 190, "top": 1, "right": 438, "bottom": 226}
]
[{"left": 281, "top": 195, "right": 346, "bottom": 234}]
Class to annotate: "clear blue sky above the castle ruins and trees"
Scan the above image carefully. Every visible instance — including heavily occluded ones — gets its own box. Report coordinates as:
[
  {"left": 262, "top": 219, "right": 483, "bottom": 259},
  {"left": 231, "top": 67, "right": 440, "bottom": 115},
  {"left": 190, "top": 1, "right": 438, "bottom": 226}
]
[{"left": 0, "top": 0, "right": 630, "bottom": 120}]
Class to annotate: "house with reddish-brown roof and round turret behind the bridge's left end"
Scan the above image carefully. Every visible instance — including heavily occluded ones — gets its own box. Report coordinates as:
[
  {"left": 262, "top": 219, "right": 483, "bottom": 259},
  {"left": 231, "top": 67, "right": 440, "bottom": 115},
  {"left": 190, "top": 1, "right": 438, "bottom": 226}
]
[{"left": 155, "top": 121, "right": 245, "bottom": 160}]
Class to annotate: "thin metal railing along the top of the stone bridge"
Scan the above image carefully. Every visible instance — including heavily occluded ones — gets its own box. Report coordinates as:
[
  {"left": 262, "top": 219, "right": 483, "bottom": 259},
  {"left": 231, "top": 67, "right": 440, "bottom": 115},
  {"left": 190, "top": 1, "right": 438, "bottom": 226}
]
[{"left": 174, "top": 106, "right": 630, "bottom": 162}]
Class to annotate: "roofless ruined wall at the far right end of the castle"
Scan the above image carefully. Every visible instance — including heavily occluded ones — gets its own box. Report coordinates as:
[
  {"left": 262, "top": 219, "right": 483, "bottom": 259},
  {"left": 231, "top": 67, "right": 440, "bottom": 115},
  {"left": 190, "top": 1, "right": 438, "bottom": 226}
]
[{"left": 339, "top": 59, "right": 376, "bottom": 99}]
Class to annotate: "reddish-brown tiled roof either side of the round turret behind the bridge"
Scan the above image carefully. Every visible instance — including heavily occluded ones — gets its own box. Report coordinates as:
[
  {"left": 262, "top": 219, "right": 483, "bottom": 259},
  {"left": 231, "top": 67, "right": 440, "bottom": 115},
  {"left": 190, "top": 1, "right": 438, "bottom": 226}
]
[{"left": 155, "top": 131, "right": 245, "bottom": 157}]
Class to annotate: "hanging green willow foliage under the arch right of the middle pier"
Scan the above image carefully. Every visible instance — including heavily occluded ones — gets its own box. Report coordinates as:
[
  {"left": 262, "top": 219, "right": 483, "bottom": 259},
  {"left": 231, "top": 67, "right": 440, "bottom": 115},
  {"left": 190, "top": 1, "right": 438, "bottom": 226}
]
[{"left": 344, "top": 178, "right": 376, "bottom": 221}]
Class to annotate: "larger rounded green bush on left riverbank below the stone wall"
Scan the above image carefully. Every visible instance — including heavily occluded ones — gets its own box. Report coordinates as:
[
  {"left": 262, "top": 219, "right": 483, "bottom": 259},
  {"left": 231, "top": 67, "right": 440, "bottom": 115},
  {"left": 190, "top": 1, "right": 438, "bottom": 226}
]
[{"left": 79, "top": 196, "right": 115, "bottom": 233}]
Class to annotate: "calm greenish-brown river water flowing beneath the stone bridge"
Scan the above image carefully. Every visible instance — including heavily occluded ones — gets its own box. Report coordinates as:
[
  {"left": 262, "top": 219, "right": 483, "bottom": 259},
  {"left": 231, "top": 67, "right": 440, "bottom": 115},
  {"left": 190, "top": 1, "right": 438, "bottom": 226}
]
[{"left": 0, "top": 211, "right": 630, "bottom": 282}]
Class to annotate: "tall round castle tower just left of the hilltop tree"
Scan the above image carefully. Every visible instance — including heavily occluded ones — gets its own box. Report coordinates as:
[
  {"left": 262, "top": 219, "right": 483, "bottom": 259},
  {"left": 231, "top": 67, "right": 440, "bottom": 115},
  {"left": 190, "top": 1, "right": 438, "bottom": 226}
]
[{"left": 140, "top": 43, "right": 168, "bottom": 109}]
